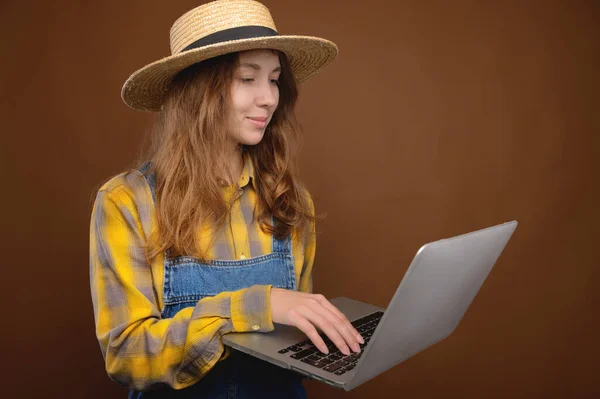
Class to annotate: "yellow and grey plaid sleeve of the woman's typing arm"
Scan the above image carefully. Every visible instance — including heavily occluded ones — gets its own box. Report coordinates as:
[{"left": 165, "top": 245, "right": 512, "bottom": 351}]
[{"left": 90, "top": 188, "right": 274, "bottom": 390}]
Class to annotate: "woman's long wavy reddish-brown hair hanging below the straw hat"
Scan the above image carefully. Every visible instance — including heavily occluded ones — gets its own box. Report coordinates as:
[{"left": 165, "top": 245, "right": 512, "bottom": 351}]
[{"left": 138, "top": 50, "right": 317, "bottom": 261}]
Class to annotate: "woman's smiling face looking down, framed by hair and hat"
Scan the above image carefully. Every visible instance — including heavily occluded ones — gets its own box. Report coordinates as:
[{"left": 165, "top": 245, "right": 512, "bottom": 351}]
[{"left": 228, "top": 50, "right": 281, "bottom": 145}]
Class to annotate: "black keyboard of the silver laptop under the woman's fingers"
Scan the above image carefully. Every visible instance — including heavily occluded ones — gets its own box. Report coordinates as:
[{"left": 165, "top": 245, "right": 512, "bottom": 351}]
[{"left": 279, "top": 312, "right": 383, "bottom": 375}]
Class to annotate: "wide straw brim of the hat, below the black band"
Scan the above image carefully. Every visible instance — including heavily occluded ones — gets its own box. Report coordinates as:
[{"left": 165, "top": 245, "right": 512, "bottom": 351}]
[{"left": 121, "top": 35, "right": 338, "bottom": 112}]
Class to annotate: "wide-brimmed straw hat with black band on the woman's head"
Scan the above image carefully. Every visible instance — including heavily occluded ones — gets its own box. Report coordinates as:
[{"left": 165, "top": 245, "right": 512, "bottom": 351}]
[{"left": 121, "top": 0, "right": 338, "bottom": 111}]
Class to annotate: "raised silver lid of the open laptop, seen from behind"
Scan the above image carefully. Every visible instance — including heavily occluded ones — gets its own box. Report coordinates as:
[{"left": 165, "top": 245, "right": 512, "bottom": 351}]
[{"left": 344, "top": 221, "right": 517, "bottom": 390}]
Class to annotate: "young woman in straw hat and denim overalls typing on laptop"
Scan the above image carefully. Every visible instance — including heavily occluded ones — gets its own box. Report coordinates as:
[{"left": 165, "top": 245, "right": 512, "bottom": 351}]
[{"left": 90, "top": 0, "right": 363, "bottom": 398}]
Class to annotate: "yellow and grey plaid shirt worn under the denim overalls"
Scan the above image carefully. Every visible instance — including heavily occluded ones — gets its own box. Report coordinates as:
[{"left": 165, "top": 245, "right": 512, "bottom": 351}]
[{"left": 90, "top": 158, "right": 316, "bottom": 390}]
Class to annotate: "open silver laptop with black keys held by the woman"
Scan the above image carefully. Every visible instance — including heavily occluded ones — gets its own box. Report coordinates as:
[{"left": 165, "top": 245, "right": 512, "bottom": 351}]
[{"left": 223, "top": 221, "right": 517, "bottom": 391}]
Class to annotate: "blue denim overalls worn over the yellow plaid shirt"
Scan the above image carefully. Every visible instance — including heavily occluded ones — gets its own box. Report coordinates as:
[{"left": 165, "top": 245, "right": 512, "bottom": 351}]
[{"left": 129, "top": 162, "right": 306, "bottom": 399}]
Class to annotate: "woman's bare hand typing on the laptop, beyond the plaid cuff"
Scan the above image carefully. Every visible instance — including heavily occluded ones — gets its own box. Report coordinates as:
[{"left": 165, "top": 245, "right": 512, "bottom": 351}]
[{"left": 271, "top": 288, "right": 364, "bottom": 355}]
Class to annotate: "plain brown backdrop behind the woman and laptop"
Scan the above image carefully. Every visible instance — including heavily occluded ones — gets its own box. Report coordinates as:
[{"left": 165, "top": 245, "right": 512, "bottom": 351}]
[{"left": 0, "top": 0, "right": 600, "bottom": 398}]
